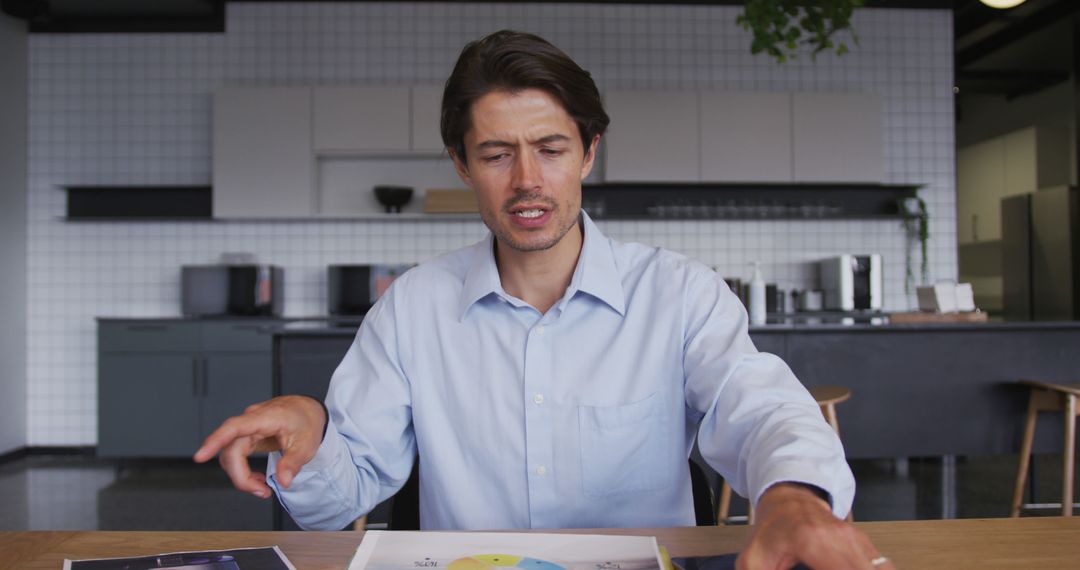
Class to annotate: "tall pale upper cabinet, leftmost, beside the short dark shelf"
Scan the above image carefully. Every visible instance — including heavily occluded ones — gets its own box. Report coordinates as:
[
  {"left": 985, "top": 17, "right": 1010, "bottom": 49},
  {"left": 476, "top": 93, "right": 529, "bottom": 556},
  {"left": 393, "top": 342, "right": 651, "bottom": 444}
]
[{"left": 213, "top": 87, "right": 314, "bottom": 218}]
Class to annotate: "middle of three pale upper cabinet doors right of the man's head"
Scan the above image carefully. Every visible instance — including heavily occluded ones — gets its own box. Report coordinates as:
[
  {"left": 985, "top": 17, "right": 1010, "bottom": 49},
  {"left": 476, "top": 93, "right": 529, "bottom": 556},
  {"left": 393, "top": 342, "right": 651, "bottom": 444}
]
[{"left": 701, "top": 92, "right": 793, "bottom": 182}]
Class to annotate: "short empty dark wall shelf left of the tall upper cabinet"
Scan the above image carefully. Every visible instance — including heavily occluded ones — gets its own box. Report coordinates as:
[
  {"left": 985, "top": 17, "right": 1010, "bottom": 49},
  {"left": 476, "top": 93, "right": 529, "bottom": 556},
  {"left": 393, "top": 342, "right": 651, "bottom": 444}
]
[{"left": 64, "top": 186, "right": 213, "bottom": 221}]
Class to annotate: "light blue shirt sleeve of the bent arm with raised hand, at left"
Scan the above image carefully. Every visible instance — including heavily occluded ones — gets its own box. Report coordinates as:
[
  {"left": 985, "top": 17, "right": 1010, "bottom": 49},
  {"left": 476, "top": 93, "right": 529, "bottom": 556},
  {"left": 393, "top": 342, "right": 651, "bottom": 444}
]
[{"left": 267, "top": 282, "right": 416, "bottom": 530}]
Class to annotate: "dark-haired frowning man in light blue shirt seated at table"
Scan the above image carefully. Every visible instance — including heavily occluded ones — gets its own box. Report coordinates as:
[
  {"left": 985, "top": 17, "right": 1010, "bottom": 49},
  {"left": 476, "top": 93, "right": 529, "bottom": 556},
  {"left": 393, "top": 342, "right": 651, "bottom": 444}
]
[{"left": 195, "top": 31, "right": 888, "bottom": 568}]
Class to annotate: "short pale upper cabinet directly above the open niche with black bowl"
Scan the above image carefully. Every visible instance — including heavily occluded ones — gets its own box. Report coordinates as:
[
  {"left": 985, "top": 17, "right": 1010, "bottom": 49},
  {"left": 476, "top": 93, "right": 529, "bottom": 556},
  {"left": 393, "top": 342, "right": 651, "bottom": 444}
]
[{"left": 312, "top": 86, "right": 409, "bottom": 153}]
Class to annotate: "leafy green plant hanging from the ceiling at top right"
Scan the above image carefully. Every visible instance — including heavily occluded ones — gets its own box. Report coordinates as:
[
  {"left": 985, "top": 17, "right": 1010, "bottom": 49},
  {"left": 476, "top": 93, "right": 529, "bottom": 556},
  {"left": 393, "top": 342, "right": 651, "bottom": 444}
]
[{"left": 735, "top": 0, "right": 863, "bottom": 64}]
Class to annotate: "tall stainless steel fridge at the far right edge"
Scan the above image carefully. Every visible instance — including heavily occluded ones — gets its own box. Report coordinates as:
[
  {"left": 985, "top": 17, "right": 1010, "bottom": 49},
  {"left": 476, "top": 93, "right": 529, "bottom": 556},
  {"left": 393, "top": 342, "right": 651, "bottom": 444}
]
[{"left": 1001, "top": 186, "right": 1080, "bottom": 321}]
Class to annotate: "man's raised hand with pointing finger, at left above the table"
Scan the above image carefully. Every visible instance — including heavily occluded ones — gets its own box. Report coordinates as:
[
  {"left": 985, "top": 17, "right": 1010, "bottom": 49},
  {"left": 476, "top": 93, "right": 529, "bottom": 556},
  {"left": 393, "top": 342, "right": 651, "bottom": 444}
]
[{"left": 194, "top": 396, "right": 327, "bottom": 499}]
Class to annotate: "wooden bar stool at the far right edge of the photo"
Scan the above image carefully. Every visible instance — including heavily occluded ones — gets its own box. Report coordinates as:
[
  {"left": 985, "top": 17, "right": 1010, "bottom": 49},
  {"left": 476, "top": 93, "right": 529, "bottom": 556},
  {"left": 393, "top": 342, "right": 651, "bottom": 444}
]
[{"left": 1010, "top": 380, "right": 1080, "bottom": 517}]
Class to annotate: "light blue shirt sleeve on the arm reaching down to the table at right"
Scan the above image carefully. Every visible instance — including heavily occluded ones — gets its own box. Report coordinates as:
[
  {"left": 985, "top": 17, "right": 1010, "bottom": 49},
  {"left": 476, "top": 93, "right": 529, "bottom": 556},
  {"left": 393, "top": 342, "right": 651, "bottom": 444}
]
[{"left": 684, "top": 267, "right": 855, "bottom": 517}]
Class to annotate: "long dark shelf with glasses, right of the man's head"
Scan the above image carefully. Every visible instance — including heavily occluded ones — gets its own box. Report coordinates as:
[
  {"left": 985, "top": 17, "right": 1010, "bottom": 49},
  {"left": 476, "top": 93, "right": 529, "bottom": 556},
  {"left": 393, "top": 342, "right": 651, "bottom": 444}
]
[{"left": 581, "top": 184, "right": 919, "bottom": 220}]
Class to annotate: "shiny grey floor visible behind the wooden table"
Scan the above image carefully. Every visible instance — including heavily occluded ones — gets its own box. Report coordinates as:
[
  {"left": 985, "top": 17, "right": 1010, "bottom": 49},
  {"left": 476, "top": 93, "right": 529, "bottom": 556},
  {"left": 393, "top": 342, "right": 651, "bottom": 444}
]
[{"left": 0, "top": 456, "right": 1075, "bottom": 530}]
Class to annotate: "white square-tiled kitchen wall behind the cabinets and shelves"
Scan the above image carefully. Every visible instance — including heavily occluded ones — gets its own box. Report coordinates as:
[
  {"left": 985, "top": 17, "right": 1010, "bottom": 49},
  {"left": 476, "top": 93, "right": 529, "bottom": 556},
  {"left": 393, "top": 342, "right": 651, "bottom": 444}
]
[{"left": 28, "top": 2, "right": 957, "bottom": 446}]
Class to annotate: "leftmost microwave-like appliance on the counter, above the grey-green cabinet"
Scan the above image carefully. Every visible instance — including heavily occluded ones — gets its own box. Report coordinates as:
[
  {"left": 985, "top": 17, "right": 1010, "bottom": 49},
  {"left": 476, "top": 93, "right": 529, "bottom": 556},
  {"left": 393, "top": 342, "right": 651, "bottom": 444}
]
[{"left": 180, "top": 264, "right": 285, "bottom": 316}]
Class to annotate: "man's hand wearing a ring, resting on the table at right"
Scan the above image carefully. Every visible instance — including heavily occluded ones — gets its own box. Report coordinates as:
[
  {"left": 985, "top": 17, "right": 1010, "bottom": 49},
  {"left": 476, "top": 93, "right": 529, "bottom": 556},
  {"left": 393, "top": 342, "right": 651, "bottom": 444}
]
[{"left": 735, "top": 483, "right": 895, "bottom": 570}]
